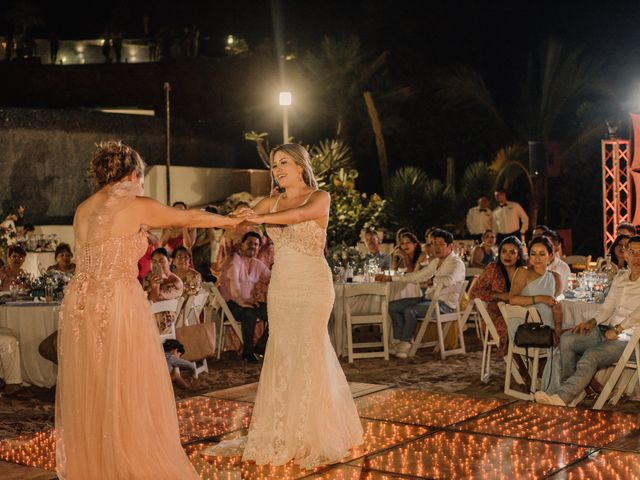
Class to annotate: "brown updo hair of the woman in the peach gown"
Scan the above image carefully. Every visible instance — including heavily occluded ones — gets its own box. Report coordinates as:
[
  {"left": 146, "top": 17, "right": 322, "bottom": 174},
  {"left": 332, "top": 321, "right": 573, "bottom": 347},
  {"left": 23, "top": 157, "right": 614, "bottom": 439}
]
[{"left": 87, "top": 140, "right": 144, "bottom": 188}]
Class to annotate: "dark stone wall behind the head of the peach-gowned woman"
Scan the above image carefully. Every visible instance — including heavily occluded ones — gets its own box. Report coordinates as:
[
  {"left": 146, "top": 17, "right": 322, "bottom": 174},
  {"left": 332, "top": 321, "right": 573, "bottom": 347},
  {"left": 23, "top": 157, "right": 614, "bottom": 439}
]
[{"left": 0, "top": 108, "right": 260, "bottom": 224}]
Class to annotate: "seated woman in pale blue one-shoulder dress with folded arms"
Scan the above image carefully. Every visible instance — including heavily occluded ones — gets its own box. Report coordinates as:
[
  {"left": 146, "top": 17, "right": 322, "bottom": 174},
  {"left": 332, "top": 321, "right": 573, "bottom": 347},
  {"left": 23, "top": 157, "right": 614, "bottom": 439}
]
[{"left": 507, "top": 237, "right": 562, "bottom": 338}]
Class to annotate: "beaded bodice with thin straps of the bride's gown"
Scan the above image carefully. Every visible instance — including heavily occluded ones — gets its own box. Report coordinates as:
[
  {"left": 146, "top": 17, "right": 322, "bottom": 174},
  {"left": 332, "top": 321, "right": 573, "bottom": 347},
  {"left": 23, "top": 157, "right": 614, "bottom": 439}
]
[{"left": 267, "top": 192, "right": 327, "bottom": 258}]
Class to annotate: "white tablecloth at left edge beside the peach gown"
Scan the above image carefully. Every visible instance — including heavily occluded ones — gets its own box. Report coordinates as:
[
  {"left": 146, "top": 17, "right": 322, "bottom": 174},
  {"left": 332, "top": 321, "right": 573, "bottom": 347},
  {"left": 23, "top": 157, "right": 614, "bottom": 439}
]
[{"left": 0, "top": 303, "right": 60, "bottom": 388}]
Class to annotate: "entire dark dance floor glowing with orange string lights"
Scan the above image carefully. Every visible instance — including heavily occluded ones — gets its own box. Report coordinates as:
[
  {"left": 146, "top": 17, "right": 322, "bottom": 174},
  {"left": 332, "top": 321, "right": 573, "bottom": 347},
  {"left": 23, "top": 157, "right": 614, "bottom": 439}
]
[{"left": 0, "top": 383, "right": 640, "bottom": 480}]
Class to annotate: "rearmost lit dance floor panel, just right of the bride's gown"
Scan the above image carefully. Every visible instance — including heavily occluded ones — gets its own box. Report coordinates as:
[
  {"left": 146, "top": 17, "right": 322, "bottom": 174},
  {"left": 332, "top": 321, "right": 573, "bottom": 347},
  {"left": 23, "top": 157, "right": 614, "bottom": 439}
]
[{"left": 356, "top": 389, "right": 509, "bottom": 427}]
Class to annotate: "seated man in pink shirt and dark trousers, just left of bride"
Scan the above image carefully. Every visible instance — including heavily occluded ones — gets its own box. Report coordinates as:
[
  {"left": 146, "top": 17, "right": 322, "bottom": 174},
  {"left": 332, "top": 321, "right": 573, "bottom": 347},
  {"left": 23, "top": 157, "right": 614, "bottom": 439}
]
[{"left": 220, "top": 232, "right": 271, "bottom": 363}]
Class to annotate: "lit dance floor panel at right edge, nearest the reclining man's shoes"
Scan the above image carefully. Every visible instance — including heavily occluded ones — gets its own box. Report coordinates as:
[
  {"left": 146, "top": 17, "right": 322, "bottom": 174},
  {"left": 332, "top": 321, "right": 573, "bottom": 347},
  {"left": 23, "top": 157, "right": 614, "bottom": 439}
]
[{"left": 456, "top": 403, "right": 640, "bottom": 447}]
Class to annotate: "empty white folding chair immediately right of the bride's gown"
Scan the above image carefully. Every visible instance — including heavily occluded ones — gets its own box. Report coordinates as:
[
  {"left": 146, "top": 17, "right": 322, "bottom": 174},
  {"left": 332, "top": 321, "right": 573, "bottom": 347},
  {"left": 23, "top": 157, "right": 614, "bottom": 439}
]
[{"left": 344, "top": 283, "right": 389, "bottom": 363}]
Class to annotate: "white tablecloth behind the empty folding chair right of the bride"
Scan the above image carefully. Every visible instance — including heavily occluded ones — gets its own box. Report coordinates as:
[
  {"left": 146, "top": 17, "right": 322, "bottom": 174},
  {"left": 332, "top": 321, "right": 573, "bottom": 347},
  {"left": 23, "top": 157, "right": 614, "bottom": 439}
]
[{"left": 329, "top": 282, "right": 422, "bottom": 357}]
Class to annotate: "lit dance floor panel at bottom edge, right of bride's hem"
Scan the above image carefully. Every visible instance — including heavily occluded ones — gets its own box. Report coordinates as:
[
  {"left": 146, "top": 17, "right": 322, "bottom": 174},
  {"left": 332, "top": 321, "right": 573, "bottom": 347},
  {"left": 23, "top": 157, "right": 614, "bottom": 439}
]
[{"left": 358, "top": 431, "right": 589, "bottom": 480}]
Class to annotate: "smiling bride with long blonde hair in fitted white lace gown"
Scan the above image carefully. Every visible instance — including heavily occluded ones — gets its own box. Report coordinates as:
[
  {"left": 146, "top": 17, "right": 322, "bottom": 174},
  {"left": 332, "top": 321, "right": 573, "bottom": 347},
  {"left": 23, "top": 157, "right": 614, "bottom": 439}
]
[{"left": 238, "top": 144, "right": 363, "bottom": 468}]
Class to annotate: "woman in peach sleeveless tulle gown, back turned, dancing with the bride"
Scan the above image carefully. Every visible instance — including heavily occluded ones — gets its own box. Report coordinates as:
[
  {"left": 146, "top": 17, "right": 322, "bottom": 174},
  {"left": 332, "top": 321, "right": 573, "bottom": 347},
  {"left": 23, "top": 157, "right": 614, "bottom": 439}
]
[{"left": 55, "top": 142, "right": 241, "bottom": 480}]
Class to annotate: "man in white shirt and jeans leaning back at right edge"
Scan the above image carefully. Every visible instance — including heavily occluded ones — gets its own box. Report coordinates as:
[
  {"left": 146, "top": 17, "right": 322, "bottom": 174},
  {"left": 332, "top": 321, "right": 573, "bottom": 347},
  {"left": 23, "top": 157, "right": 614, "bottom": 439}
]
[{"left": 535, "top": 236, "right": 640, "bottom": 406}]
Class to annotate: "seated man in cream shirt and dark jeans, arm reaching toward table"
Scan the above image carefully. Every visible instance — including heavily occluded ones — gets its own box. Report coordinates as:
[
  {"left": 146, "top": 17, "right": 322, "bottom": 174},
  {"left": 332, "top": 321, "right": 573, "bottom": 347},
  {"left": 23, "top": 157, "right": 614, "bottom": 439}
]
[{"left": 376, "top": 229, "right": 465, "bottom": 358}]
